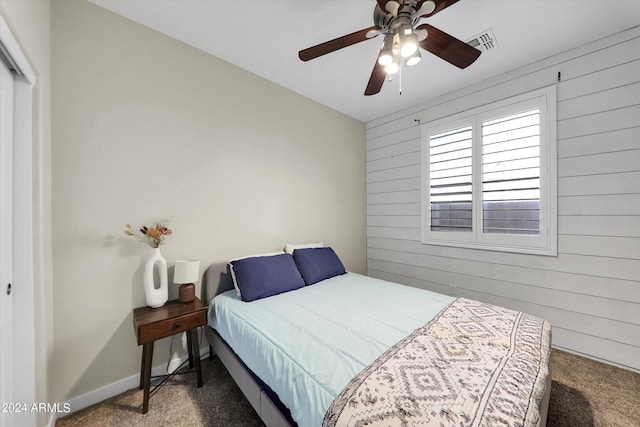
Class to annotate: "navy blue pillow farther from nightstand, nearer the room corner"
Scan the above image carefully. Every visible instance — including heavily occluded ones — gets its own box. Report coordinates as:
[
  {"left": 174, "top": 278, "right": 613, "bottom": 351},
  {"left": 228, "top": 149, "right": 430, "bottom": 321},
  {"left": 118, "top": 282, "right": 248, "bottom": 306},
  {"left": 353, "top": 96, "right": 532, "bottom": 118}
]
[{"left": 293, "top": 248, "right": 346, "bottom": 285}]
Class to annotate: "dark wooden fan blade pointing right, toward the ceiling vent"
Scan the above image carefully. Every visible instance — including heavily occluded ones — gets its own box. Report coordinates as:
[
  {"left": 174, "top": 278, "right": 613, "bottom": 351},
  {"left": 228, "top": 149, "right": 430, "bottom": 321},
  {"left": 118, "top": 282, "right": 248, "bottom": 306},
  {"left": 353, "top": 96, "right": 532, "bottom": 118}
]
[{"left": 416, "top": 24, "right": 482, "bottom": 68}]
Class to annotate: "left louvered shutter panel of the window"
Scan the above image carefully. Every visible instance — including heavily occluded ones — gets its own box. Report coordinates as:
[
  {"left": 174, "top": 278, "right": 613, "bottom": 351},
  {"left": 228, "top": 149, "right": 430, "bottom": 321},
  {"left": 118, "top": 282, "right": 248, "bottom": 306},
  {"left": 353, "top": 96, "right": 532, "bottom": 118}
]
[{"left": 429, "top": 126, "right": 473, "bottom": 232}]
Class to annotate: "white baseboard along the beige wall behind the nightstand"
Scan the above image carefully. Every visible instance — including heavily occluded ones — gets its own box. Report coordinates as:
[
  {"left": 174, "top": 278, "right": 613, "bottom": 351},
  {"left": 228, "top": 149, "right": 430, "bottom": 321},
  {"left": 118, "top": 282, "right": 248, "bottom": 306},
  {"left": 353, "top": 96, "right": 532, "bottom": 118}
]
[{"left": 47, "top": 344, "right": 209, "bottom": 427}]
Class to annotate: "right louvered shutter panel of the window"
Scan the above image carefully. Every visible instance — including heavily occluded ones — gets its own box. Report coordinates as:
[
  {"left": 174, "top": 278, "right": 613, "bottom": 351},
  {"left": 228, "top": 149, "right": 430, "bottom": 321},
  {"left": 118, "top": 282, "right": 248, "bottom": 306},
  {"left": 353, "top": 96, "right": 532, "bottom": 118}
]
[{"left": 482, "top": 109, "right": 540, "bottom": 235}]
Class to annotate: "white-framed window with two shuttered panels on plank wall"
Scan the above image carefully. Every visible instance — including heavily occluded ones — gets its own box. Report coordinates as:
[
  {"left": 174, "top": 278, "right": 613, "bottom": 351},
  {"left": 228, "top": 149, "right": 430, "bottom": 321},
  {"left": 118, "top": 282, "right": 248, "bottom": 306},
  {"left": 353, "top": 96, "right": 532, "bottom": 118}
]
[{"left": 422, "top": 87, "right": 557, "bottom": 255}]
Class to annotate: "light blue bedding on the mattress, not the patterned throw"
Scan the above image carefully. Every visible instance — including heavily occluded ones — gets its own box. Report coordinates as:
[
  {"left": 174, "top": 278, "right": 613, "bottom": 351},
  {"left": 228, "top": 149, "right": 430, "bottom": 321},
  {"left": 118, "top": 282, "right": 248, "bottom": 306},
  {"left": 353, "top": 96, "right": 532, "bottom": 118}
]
[{"left": 209, "top": 273, "right": 455, "bottom": 427}]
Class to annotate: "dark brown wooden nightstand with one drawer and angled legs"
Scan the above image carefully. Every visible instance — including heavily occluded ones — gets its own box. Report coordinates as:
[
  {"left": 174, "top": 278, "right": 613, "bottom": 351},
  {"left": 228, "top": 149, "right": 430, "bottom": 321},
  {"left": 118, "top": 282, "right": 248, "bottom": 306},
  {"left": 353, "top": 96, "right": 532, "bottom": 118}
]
[{"left": 133, "top": 298, "right": 207, "bottom": 414}]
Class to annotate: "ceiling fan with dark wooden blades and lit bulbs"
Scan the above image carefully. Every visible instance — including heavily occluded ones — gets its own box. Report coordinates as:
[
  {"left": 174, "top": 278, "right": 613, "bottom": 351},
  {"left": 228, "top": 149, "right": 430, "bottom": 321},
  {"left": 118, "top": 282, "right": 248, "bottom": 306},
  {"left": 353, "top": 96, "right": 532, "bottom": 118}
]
[{"left": 298, "top": 0, "right": 481, "bottom": 95}]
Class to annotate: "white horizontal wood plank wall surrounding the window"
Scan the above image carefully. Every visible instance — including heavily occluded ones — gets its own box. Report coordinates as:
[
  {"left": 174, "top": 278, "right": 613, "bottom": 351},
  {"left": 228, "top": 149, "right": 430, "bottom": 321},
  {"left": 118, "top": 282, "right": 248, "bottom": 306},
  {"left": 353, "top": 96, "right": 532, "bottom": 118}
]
[{"left": 366, "top": 27, "right": 640, "bottom": 371}]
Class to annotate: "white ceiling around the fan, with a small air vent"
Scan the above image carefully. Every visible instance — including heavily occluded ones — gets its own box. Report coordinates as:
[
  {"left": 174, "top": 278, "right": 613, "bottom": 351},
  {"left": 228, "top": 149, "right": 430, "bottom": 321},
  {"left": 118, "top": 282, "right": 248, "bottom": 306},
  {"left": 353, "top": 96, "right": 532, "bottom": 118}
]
[{"left": 91, "top": 0, "right": 640, "bottom": 122}]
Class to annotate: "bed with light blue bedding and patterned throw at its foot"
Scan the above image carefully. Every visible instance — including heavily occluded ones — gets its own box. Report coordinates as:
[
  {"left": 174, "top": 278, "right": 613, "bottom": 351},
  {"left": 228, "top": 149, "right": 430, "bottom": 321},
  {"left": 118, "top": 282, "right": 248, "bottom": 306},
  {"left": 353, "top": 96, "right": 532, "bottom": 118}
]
[{"left": 203, "top": 251, "right": 550, "bottom": 427}]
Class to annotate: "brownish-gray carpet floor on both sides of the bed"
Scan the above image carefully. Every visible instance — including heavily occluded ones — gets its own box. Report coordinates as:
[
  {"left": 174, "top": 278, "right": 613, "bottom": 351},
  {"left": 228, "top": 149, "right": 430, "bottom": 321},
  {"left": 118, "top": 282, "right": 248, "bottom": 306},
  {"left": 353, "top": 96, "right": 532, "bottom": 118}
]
[{"left": 56, "top": 350, "right": 640, "bottom": 427}]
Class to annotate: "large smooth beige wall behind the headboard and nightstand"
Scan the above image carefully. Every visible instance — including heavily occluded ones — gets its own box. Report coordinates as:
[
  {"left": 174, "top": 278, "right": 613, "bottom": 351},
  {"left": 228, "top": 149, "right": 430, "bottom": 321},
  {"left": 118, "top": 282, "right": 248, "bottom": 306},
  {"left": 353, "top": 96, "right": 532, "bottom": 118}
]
[{"left": 52, "top": 1, "right": 366, "bottom": 400}]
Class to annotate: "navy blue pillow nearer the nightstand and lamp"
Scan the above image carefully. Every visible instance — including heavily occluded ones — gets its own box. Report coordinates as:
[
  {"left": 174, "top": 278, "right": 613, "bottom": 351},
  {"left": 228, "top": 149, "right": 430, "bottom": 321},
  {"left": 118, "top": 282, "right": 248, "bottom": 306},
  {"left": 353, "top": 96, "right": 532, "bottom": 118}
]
[{"left": 230, "top": 254, "right": 304, "bottom": 302}]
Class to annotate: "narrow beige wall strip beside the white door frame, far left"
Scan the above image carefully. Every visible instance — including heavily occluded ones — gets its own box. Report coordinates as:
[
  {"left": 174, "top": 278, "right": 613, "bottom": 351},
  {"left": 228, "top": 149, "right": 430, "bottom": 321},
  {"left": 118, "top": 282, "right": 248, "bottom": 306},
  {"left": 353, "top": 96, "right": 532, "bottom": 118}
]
[{"left": 0, "top": 0, "right": 53, "bottom": 425}]
